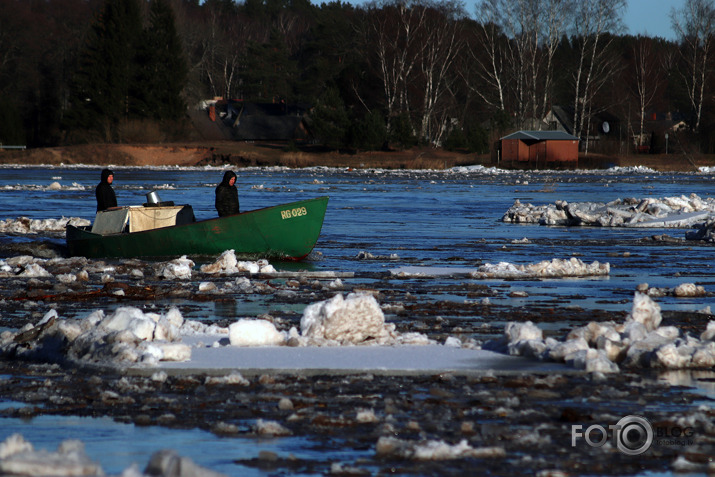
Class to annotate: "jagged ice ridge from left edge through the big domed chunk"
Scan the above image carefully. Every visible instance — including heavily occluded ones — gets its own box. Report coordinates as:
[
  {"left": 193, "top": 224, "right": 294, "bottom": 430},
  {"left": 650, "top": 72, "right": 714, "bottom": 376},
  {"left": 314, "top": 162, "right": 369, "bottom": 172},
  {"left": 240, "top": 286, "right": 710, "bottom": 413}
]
[{"left": 0, "top": 293, "right": 434, "bottom": 367}]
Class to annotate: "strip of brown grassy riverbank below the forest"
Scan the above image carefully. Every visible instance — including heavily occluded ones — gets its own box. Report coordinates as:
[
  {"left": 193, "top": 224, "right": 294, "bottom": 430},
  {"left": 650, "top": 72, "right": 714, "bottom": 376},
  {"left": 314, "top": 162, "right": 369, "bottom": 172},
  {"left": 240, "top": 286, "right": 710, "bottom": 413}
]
[{"left": 0, "top": 141, "right": 715, "bottom": 172}]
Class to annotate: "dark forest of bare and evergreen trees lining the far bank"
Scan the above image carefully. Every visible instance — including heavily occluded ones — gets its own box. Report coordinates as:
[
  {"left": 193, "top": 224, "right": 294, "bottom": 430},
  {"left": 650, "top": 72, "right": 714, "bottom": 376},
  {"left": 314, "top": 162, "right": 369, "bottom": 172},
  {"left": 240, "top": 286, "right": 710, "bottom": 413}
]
[{"left": 0, "top": 0, "right": 715, "bottom": 154}]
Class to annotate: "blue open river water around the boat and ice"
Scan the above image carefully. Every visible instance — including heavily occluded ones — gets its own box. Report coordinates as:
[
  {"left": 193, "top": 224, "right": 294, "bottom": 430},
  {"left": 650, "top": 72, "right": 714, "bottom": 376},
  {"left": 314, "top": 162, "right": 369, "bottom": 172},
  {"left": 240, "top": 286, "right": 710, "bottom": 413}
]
[{"left": 0, "top": 166, "right": 715, "bottom": 475}]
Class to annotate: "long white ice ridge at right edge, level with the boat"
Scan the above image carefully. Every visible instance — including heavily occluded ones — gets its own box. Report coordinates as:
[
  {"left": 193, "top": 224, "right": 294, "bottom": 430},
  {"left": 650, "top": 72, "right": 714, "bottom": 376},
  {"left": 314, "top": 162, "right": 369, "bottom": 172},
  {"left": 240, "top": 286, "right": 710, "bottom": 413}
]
[{"left": 502, "top": 194, "right": 715, "bottom": 228}]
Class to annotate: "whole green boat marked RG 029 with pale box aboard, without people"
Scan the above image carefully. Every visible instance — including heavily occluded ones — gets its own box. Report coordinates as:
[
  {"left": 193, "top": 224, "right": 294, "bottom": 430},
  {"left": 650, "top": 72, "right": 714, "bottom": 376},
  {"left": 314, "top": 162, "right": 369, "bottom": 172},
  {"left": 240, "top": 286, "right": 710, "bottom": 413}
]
[{"left": 67, "top": 197, "right": 328, "bottom": 260}]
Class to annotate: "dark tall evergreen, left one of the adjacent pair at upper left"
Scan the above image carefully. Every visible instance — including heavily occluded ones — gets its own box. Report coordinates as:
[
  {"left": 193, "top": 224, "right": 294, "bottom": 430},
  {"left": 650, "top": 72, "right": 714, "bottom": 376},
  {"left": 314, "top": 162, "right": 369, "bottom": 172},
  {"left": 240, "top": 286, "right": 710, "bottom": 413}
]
[{"left": 67, "top": 0, "right": 142, "bottom": 140}]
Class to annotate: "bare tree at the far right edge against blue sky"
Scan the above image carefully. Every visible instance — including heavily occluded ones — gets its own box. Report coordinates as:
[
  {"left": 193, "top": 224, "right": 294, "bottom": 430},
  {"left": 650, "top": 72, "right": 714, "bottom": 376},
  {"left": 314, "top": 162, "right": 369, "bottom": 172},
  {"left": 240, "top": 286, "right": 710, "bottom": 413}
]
[{"left": 670, "top": 0, "right": 715, "bottom": 131}]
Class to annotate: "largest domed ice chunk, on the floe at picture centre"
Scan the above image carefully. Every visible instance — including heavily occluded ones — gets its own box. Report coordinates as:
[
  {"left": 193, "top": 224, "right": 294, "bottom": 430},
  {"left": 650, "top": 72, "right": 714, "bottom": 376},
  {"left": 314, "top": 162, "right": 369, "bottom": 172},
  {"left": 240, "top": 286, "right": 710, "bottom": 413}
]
[{"left": 300, "top": 293, "right": 389, "bottom": 344}]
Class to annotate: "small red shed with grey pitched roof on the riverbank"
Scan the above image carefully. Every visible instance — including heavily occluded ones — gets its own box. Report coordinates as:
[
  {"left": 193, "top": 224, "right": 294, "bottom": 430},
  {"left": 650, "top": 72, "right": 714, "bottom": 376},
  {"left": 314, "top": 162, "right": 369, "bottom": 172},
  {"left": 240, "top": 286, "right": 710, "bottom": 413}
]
[{"left": 500, "top": 131, "right": 579, "bottom": 169}]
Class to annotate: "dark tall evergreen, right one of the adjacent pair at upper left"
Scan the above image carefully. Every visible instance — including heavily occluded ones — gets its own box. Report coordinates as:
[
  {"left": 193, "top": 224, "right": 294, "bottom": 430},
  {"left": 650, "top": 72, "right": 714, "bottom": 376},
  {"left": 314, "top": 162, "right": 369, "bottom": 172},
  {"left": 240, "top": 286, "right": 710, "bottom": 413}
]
[{"left": 130, "top": 0, "right": 188, "bottom": 120}]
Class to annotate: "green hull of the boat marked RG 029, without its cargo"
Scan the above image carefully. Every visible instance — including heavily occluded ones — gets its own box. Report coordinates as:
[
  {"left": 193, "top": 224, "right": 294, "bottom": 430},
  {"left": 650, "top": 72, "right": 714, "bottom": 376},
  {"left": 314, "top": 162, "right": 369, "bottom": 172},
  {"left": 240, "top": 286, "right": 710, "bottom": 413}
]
[{"left": 67, "top": 197, "right": 328, "bottom": 260}]
